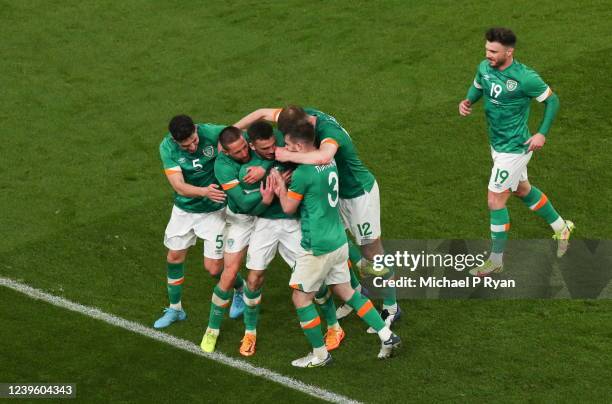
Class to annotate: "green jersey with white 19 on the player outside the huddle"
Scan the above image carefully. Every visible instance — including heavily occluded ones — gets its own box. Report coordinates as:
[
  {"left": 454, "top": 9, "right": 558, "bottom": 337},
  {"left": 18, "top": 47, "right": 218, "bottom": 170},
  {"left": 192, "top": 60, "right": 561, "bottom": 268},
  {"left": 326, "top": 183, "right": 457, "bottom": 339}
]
[{"left": 474, "top": 59, "right": 552, "bottom": 153}]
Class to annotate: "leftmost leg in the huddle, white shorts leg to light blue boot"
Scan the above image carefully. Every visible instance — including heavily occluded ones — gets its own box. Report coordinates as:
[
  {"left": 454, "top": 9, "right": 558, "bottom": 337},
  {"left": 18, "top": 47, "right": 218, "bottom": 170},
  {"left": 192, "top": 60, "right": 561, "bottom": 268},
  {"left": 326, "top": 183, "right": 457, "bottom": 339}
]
[{"left": 153, "top": 206, "right": 201, "bottom": 328}]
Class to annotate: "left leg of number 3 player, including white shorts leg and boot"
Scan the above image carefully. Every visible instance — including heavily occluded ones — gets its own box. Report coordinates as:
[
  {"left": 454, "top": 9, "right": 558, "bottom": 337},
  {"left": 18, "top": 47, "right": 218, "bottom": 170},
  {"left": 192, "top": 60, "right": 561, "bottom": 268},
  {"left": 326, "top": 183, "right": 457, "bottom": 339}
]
[{"left": 289, "top": 252, "right": 331, "bottom": 368}]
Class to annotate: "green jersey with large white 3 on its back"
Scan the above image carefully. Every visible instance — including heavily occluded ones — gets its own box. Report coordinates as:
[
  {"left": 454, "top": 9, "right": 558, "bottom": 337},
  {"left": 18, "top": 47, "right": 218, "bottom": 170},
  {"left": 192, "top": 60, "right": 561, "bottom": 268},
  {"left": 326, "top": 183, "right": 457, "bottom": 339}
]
[{"left": 287, "top": 161, "right": 347, "bottom": 255}]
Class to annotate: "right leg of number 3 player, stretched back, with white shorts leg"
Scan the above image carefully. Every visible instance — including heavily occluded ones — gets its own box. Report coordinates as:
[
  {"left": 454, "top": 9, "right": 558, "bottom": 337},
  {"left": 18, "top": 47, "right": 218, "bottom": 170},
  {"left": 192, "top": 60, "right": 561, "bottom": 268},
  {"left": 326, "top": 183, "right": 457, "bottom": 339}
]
[{"left": 325, "top": 245, "right": 400, "bottom": 358}]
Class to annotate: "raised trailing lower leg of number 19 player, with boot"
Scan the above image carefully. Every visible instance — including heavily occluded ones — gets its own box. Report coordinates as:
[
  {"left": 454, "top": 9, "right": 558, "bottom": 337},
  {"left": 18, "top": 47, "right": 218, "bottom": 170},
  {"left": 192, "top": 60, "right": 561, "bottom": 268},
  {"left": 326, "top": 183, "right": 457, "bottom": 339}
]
[{"left": 514, "top": 181, "right": 574, "bottom": 257}]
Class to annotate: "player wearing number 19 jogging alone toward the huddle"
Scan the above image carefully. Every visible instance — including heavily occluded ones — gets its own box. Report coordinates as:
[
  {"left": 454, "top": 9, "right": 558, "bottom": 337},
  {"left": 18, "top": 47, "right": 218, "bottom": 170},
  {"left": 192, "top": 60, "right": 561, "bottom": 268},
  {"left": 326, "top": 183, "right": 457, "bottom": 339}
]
[{"left": 459, "top": 28, "right": 574, "bottom": 276}]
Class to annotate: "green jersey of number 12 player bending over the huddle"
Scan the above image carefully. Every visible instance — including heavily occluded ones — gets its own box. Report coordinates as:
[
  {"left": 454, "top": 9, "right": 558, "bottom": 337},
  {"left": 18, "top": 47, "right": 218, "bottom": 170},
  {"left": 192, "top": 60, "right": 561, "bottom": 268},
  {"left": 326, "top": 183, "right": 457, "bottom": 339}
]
[{"left": 304, "top": 108, "right": 375, "bottom": 199}]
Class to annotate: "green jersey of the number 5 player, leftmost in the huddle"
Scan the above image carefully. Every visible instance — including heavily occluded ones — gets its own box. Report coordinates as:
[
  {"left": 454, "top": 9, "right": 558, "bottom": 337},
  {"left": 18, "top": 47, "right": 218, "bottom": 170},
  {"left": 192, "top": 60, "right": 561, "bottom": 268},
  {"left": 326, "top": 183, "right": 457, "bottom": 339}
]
[{"left": 159, "top": 123, "right": 225, "bottom": 213}]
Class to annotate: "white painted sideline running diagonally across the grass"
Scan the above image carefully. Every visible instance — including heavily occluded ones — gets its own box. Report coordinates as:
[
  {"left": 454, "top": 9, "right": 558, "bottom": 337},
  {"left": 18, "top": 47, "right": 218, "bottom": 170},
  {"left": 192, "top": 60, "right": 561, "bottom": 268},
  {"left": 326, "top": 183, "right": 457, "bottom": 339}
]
[{"left": 0, "top": 277, "right": 359, "bottom": 404}]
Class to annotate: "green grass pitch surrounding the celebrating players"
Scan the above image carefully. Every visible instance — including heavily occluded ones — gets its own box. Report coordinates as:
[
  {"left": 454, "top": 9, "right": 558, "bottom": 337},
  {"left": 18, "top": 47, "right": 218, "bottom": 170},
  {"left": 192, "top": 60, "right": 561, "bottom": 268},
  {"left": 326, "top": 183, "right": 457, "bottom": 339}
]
[{"left": 0, "top": 0, "right": 612, "bottom": 402}]
